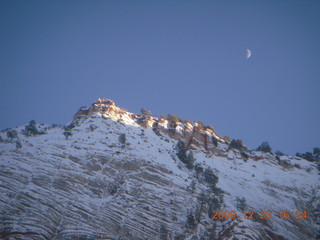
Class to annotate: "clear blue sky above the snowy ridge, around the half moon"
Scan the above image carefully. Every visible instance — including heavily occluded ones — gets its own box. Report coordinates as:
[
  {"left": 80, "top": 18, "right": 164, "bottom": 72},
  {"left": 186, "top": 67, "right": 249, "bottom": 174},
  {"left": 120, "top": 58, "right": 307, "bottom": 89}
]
[{"left": 0, "top": 0, "right": 320, "bottom": 154}]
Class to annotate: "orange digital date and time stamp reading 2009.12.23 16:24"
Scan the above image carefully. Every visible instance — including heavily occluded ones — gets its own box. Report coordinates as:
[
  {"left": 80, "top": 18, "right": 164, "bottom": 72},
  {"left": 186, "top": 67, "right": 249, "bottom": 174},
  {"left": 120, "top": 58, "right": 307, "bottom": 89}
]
[{"left": 211, "top": 211, "right": 307, "bottom": 219}]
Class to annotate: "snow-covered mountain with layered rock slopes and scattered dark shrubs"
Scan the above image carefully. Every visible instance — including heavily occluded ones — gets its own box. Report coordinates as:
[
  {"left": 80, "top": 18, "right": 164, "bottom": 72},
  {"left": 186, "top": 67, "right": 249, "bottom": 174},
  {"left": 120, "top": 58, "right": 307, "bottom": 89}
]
[{"left": 0, "top": 99, "right": 320, "bottom": 240}]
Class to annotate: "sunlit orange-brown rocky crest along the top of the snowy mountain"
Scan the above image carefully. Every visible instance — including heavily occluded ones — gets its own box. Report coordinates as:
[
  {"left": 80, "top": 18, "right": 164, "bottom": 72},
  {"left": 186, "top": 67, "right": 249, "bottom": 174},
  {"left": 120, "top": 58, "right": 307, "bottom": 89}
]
[{"left": 74, "top": 98, "right": 226, "bottom": 155}]
